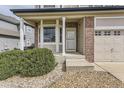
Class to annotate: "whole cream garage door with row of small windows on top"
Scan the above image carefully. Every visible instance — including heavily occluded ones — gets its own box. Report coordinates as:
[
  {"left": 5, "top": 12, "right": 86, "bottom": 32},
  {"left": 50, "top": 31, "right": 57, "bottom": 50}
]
[{"left": 94, "top": 31, "right": 124, "bottom": 62}]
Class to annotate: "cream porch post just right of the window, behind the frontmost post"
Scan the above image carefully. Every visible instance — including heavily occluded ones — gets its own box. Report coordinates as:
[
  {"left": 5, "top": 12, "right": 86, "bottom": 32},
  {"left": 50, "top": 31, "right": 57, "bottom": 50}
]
[{"left": 56, "top": 19, "right": 60, "bottom": 52}]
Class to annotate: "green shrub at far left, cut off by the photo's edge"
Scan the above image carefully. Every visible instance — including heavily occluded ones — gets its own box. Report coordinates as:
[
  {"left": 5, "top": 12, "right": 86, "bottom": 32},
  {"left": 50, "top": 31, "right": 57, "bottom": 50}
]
[{"left": 0, "top": 50, "right": 23, "bottom": 80}]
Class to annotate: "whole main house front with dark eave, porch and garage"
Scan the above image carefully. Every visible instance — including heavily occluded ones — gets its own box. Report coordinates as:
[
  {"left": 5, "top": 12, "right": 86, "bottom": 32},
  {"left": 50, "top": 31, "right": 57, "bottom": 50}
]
[{"left": 11, "top": 6, "right": 124, "bottom": 62}]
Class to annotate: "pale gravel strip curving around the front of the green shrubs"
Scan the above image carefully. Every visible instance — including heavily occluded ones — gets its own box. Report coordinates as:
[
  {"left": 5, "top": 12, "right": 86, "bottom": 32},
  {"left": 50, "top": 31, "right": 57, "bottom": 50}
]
[{"left": 0, "top": 64, "right": 63, "bottom": 88}]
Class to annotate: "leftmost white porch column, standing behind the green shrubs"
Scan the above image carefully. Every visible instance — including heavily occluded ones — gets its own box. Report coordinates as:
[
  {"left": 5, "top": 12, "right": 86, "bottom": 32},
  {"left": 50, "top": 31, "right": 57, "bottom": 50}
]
[{"left": 20, "top": 18, "right": 24, "bottom": 50}]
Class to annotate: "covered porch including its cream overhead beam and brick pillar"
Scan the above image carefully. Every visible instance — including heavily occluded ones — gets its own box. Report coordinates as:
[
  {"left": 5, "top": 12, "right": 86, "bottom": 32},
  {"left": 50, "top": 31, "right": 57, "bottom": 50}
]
[{"left": 13, "top": 9, "right": 94, "bottom": 62}]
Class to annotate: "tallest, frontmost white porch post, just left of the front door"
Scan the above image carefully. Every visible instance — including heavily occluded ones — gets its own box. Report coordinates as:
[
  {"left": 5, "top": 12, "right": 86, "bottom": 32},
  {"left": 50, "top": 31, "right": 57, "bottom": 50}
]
[{"left": 62, "top": 17, "right": 65, "bottom": 55}]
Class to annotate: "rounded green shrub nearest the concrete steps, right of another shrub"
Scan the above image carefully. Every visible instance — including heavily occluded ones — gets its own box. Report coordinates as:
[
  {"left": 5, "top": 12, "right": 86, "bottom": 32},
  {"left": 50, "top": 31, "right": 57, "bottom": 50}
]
[{"left": 20, "top": 48, "right": 56, "bottom": 76}]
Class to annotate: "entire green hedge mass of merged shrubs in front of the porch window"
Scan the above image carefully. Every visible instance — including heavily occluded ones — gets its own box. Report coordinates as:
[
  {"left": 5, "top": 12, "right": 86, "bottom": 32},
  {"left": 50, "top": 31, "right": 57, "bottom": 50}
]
[{"left": 0, "top": 48, "right": 56, "bottom": 80}]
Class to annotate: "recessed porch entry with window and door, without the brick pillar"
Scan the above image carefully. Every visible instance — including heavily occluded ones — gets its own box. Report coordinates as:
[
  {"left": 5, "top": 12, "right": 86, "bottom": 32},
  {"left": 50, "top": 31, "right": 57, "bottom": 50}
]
[{"left": 32, "top": 17, "right": 85, "bottom": 55}]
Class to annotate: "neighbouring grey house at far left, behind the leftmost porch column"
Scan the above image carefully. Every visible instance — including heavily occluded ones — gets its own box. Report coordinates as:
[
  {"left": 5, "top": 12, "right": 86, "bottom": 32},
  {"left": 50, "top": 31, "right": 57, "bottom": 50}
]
[{"left": 0, "top": 6, "right": 34, "bottom": 52}]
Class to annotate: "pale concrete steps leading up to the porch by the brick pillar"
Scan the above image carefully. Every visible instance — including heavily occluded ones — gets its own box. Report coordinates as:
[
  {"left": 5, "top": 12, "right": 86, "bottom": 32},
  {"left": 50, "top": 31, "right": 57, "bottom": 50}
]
[{"left": 65, "top": 54, "right": 94, "bottom": 71}]
